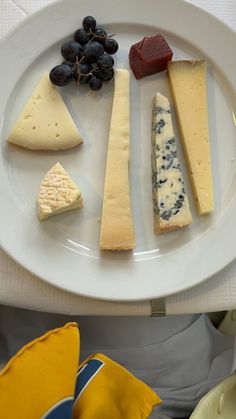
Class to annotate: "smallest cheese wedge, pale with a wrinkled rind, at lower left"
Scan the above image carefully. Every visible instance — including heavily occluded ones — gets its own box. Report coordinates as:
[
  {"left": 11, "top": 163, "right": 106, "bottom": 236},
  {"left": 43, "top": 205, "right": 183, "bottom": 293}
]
[{"left": 38, "top": 163, "right": 83, "bottom": 220}]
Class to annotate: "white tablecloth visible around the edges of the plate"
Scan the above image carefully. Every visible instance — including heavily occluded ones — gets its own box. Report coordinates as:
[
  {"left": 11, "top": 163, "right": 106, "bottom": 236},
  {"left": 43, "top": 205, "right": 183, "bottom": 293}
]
[{"left": 0, "top": 0, "right": 236, "bottom": 315}]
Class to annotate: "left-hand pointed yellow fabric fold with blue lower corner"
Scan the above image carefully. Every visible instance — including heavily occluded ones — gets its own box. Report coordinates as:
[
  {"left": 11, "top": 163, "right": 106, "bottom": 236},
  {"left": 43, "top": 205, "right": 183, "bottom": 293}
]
[{"left": 0, "top": 323, "right": 80, "bottom": 419}]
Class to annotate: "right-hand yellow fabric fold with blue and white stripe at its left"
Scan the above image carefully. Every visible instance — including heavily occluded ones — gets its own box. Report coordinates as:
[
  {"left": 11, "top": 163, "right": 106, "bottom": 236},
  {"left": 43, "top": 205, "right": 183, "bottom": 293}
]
[{"left": 73, "top": 354, "right": 161, "bottom": 419}]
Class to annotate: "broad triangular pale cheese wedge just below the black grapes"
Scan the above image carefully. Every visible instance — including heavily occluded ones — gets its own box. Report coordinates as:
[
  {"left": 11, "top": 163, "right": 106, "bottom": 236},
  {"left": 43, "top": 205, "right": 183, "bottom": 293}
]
[{"left": 8, "top": 73, "right": 83, "bottom": 150}]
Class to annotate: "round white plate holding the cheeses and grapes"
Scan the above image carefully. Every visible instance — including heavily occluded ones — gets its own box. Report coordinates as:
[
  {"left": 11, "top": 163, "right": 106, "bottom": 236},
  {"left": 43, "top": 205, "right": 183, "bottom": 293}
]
[{"left": 0, "top": 0, "right": 236, "bottom": 300}]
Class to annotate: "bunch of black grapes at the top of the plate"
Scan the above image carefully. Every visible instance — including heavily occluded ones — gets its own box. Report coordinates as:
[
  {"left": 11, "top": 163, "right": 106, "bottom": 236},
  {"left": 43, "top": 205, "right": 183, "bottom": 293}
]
[{"left": 49, "top": 16, "right": 119, "bottom": 90}]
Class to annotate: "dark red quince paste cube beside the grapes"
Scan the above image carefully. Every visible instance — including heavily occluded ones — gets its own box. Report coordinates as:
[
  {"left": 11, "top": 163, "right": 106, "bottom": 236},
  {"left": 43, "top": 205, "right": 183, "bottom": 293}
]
[{"left": 129, "top": 34, "right": 173, "bottom": 79}]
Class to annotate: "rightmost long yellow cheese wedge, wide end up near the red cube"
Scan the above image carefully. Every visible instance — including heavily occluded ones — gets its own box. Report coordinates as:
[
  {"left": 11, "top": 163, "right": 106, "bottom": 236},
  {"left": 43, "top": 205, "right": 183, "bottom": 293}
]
[{"left": 168, "top": 60, "right": 214, "bottom": 215}]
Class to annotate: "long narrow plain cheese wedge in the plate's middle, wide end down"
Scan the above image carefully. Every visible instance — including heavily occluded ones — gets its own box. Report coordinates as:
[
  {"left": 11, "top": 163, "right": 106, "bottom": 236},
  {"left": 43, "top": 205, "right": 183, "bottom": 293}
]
[{"left": 100, "top": 69, "right": 135, "bottom": 250}]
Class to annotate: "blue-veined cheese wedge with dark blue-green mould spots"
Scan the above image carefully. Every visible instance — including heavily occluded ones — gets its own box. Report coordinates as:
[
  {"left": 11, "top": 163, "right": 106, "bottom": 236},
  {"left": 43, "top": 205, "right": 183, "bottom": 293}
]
[{"left": 152, "top": 93, "right": 192, "bottom": 234}]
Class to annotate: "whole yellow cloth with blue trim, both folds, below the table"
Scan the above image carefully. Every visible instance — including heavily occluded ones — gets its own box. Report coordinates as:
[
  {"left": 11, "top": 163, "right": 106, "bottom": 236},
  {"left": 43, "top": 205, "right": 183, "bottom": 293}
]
[{"left": 0, "top": 323, "right": 161, "bottom": 419}]
